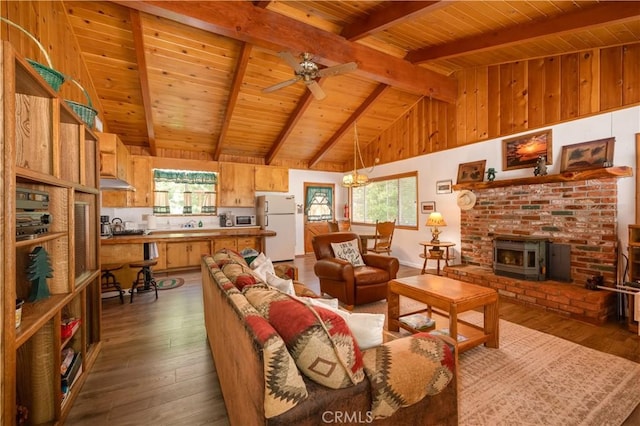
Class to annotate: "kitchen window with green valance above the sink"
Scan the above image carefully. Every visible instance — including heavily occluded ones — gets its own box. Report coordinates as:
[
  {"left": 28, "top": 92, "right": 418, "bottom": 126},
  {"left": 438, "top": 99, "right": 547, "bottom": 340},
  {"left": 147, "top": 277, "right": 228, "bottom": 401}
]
[{"left": 153, "top": 169, "right": 218, "bottom": 214}]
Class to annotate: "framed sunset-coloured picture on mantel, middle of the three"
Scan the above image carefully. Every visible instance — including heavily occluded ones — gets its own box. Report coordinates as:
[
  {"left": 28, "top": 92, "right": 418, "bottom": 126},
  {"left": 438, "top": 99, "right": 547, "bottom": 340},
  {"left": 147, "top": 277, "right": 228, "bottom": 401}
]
[{"left": 502, "top": 129, "right": 553, "bottom": 170}]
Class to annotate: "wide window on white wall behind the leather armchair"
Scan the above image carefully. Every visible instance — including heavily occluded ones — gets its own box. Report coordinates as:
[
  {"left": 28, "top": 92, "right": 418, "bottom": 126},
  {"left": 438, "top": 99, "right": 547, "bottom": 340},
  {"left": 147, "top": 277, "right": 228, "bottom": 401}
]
[{"left": 351, "top": 172, "right": 418, "bottom": 228}]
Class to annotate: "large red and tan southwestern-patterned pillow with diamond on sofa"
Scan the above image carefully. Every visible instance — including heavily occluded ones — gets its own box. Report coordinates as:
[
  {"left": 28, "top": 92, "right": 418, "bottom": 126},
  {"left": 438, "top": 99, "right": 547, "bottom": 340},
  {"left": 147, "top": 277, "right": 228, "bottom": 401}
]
[{"left": 243, "top": 286, "right": 364, "bottom": 389}]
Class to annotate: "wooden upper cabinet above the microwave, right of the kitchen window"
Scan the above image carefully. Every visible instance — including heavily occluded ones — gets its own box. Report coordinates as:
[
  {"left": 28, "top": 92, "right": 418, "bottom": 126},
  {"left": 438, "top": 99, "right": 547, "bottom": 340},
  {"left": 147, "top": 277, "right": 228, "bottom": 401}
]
[{"left": 218, "top": 163, "right": 255, "bottom": 207}]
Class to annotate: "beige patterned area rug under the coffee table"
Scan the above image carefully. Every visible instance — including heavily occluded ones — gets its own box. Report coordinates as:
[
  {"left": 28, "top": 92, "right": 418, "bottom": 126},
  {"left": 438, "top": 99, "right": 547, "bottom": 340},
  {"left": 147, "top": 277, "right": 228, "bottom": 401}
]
[{"left": 356, "top": 302, "right": 640, "bottom": 426}]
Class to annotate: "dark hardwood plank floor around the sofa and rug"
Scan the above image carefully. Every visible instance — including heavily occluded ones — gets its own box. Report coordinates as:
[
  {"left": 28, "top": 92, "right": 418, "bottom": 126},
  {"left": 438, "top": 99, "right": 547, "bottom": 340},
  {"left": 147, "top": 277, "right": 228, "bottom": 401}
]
[{"left": 65, "top": 256, "right": 640, "bottom": 426}]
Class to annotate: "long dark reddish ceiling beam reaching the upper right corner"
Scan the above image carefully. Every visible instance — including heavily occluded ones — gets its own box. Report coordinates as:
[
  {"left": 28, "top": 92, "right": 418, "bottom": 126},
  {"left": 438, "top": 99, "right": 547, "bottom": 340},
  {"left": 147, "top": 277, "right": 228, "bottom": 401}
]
[{"left": 405, "top": 1, "right": 640, "bottom": 63}]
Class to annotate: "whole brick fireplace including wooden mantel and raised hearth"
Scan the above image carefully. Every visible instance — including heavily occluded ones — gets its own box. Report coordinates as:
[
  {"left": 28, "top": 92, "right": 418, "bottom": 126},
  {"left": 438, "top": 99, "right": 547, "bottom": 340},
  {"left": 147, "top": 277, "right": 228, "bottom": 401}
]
[{"left": 445, "top": 168, "right": 630, "bottom": 324}]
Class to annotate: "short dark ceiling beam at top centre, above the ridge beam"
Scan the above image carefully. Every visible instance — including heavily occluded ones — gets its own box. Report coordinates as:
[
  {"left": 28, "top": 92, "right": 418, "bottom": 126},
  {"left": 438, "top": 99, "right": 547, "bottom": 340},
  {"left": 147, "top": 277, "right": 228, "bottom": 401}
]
[{"left": 340, "top": 1, "right": 441, "bottom": 41}]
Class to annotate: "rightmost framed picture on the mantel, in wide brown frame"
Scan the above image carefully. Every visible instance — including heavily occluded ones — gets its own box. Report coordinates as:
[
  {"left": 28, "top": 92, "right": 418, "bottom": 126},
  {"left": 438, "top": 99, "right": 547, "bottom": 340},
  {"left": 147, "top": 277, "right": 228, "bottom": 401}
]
[{"left": 560, "top": 138, "right": 616, "bottom": 173}]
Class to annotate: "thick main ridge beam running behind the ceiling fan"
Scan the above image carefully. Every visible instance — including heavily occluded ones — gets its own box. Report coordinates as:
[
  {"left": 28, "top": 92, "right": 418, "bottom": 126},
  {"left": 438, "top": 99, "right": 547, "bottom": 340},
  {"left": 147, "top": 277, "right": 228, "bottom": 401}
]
[{"left": 116, "top": 1, "right": 457, "bottom": 102}]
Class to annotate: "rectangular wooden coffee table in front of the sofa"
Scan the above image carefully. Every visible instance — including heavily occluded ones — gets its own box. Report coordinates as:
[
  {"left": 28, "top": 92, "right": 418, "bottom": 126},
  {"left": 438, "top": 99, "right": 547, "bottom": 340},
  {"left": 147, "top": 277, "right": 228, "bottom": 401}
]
[{"left": 387, "top": 275, "right": 499, "bottom": 352}]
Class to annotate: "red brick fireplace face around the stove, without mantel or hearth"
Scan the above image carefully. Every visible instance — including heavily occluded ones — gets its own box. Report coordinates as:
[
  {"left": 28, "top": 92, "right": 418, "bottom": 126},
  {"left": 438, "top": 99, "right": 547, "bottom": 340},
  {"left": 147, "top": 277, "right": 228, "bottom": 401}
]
[{"left": 460, "top": 178, "right": 618, "bottom": 285}]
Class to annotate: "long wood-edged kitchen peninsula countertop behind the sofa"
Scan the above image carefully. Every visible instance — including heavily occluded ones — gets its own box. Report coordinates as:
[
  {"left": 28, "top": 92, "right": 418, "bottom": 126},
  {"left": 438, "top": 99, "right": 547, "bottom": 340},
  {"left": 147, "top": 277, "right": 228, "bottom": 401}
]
[{"left": 100, "top": 227, "right": 276, "bottom": 245}]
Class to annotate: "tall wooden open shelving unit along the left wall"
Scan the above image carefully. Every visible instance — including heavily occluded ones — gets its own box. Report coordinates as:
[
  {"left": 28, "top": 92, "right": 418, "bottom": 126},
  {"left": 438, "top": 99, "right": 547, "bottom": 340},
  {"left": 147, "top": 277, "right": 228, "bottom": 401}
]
[{"left": 0, "top": 42, "right": 101, "bottom": 425}]
